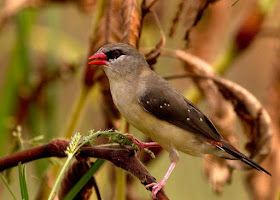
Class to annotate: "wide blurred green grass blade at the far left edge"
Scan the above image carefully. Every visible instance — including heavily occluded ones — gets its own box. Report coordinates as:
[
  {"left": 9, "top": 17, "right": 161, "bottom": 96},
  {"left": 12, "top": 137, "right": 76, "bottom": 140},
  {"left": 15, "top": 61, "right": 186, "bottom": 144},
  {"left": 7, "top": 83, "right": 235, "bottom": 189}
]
[{"left": 0, "top": 9, "right": 34, "bottom": 156}]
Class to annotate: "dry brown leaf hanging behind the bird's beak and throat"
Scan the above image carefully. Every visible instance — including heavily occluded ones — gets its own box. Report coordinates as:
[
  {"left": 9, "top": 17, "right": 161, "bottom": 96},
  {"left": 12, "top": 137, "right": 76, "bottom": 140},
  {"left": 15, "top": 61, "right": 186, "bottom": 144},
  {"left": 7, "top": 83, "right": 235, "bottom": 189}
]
[{"left": 84, "top": 0, "right": 122, "bottom": 128}]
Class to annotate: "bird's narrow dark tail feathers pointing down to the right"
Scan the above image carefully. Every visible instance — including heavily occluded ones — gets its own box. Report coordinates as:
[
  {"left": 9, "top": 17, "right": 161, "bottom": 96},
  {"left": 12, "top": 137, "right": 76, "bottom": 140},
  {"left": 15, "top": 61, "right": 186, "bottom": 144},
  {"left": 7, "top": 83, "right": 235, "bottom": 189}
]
[{"left": 218, "top": 141, "right": 271, "bottom": 176}]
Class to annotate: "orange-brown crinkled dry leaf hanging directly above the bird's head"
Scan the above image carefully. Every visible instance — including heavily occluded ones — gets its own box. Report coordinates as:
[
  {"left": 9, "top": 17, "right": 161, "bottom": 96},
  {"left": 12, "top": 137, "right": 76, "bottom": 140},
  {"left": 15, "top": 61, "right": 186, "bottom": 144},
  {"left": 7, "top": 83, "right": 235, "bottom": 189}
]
[{"left": 121, "top": 0, "right": 142, "bottom": 48}]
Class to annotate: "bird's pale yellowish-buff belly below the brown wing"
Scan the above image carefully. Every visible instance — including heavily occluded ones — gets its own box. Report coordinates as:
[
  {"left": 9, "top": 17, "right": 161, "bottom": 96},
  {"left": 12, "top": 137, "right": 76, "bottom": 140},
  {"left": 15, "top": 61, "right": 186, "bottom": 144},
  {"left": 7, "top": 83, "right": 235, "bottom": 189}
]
[{"left": 117, "top": 97, "right": 213, "bottom": 156}]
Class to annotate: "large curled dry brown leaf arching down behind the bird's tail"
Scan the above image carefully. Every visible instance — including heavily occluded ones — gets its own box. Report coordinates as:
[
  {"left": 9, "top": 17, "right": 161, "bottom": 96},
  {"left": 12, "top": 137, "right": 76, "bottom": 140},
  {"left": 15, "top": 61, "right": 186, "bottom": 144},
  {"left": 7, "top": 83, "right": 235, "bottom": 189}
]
[{"left": 212, "top": 77, "right": 272, "bottom": 169}]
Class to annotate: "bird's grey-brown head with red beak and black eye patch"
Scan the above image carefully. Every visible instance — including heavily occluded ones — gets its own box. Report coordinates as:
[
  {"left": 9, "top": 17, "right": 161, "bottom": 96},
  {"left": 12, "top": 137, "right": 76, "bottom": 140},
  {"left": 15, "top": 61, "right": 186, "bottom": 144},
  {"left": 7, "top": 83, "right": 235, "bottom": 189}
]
[{"left": 89, "top": 43, "right": 148, "bottom": 79}]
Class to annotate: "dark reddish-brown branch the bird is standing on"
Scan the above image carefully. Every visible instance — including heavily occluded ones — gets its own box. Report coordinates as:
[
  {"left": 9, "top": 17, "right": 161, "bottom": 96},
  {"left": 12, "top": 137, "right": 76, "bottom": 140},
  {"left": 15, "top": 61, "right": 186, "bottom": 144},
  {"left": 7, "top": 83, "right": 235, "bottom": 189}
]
[{"left": 0, "top": 139, "right": 168, "bottom": 200}]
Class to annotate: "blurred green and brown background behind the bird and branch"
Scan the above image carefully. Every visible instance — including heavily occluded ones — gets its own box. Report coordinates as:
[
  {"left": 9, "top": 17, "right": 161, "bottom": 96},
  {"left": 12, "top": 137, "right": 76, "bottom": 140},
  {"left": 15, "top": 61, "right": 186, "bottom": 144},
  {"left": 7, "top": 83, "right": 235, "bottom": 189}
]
[{"left": 0, "top": 0, "right": 280, "bottom": 200}]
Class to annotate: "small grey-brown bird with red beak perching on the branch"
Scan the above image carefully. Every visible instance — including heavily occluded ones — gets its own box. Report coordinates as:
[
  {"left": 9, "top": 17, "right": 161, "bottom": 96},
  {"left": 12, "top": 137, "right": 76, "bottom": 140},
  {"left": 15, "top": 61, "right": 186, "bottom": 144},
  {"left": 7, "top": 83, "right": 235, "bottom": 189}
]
[{"left": 89, "top": 43, "right": 270, "bottom": 198}]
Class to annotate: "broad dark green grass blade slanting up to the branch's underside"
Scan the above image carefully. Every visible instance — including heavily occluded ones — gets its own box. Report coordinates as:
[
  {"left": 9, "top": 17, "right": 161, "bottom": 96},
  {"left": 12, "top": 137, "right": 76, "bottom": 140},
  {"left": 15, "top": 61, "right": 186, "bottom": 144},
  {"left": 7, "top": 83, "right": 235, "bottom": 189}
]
[{"left": 63, "top": 159, "right": 105, "bottom": 200}]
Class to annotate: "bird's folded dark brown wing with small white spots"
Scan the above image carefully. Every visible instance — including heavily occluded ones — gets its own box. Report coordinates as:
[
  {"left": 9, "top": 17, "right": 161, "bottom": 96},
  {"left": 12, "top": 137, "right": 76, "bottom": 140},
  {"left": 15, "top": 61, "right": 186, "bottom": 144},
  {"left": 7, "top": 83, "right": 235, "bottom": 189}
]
[{"left": 139, "top": 87, "right": 222, "bottom": 141}]
